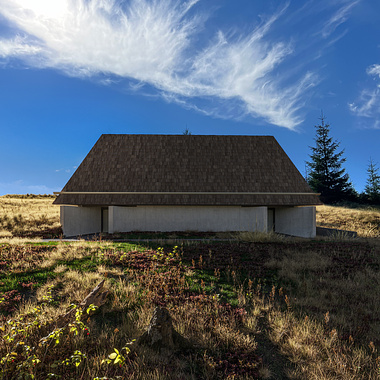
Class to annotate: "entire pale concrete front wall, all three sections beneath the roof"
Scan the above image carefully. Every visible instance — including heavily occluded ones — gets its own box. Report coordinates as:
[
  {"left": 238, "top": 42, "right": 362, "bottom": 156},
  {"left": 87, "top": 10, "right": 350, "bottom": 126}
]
[{"left": 61, "top": 206, "right": 316, "bottom": 238}]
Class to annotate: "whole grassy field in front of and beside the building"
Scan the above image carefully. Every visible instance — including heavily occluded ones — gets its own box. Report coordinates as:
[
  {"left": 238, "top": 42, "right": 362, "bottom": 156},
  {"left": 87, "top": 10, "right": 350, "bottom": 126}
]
[{"left": 0, "top": 197, "right": 380, "bottom": 380}]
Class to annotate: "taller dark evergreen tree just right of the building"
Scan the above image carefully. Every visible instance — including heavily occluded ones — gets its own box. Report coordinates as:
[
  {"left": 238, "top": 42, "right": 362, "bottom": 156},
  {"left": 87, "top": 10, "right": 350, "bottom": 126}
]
[{"left": 307, "top": 114, "right": 355, "bottom": 203}]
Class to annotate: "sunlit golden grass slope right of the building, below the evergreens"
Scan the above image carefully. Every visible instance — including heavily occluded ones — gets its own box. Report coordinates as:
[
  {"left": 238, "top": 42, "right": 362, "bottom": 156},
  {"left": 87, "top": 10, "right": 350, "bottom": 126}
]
[{"left": 317, "top": 205, "right": 380, "bottom": 238}]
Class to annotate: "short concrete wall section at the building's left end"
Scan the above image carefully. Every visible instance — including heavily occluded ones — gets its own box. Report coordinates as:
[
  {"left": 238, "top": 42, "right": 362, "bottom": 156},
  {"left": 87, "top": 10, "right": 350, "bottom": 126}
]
[{"left": 60, "top": 206, "right": 101, "bottom": 236}]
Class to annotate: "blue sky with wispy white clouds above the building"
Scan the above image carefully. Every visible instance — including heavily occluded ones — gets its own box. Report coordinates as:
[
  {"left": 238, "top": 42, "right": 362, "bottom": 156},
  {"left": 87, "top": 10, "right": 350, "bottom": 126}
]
[{"left": 0, "top": 0, "right": 380, "bottom": 195}]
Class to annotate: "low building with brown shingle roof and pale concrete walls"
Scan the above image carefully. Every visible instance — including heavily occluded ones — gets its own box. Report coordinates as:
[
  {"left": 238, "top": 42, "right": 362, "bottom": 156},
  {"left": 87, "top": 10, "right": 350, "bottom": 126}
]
[{"left": 54, "top": 135, "right": 321, "bottom": 237}]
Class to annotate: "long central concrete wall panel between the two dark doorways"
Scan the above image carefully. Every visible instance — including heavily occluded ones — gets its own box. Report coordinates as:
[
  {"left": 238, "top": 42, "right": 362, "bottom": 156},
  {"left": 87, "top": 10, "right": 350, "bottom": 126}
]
[{"left": 108, "top": 206, "right": 267, "bottom": 233}]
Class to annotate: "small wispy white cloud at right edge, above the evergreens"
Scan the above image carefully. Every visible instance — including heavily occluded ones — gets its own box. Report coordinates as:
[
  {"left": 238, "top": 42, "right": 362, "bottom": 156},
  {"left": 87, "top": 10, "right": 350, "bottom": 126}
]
[{"left": 348, "top": 64, "right": 380, "bottom": 129}]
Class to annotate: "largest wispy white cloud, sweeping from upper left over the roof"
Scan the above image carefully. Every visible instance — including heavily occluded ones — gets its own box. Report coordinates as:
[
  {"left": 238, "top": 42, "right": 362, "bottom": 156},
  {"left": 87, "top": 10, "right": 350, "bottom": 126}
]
[{"left": 0, "top": 0, "right": 346, "bottom": 129}]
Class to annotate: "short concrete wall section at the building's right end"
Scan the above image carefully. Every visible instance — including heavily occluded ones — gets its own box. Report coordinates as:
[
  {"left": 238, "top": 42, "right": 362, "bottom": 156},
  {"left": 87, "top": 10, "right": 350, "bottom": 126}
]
[{"left": 275, "top": 206, "right": 316, "bottom": 238}]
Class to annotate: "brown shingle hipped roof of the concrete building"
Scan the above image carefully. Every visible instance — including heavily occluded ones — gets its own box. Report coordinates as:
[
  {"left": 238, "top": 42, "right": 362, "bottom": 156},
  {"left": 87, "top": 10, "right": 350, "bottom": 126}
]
[{"left": 54, "top": 135, "right": 320, "bottom": 206}]
